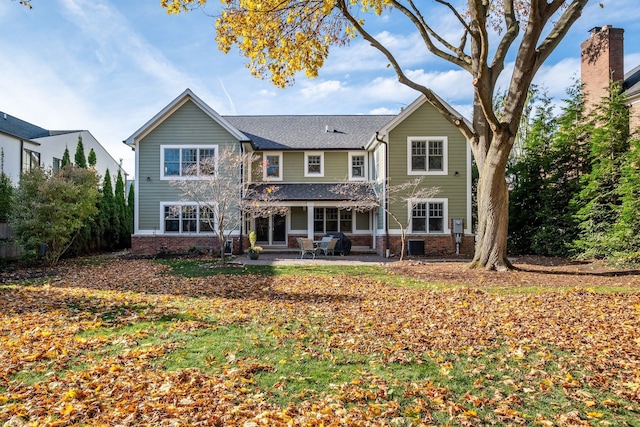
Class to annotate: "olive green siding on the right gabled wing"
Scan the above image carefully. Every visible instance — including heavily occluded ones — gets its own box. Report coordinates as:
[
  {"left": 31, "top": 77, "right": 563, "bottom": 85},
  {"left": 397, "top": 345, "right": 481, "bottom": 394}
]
[{"left": 382, "top": 102, "right": 467, "bottom": 229}]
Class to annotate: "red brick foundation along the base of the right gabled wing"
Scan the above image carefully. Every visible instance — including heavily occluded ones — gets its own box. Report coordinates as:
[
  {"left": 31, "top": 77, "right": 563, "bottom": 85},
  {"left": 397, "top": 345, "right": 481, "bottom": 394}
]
[{"left": 376, "top": 234, "right": 475, "bottom": 258}]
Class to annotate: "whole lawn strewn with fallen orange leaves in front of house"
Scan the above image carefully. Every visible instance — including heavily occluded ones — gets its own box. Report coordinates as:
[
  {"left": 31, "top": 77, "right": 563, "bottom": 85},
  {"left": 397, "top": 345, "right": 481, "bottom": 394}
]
[{"left": 0, "top": 260, "right": 640, "bottom": 427}]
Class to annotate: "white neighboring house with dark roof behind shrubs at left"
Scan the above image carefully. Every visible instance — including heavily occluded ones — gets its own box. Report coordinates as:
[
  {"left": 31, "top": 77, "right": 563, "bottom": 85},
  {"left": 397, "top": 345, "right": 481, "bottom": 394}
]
[{"left": 0, "top": 112, "right": 127, "bottom": 185}]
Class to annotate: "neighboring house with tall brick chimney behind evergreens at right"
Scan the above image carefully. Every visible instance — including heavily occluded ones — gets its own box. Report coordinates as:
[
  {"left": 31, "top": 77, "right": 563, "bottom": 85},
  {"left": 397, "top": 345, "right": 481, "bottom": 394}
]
[{"left": 580, "top": 25, "right": 640, "bottom": 133}]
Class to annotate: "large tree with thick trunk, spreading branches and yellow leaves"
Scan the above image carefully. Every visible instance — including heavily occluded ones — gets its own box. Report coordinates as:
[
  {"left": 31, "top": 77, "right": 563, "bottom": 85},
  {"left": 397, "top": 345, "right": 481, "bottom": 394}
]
[{"left": 161, "top": 0, "right": 589, "bottom": 270}]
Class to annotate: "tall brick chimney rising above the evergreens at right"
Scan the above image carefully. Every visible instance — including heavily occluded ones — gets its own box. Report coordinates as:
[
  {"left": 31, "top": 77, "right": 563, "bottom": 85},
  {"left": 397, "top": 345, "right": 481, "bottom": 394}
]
[{"left": 580, "top": 25, "right": 624, "bottom": 110}]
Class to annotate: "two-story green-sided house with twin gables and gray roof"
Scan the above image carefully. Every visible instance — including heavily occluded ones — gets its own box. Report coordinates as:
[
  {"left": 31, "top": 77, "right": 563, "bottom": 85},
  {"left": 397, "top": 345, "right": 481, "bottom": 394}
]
[{"left": 124, "top": 89, "right": 474, "bottom": 256}]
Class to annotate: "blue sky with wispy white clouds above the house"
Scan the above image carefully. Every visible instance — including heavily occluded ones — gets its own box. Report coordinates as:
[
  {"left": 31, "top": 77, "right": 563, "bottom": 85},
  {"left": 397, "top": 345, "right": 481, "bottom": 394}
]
[{"left": 0, "top": 0, "right": 640, "bottom": 176}]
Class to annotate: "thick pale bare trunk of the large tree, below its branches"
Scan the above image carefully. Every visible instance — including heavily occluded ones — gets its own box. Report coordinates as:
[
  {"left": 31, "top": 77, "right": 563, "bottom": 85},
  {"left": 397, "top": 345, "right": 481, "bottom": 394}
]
[{"left": 469, "top": 132, "right": 512, "bottom": 271}]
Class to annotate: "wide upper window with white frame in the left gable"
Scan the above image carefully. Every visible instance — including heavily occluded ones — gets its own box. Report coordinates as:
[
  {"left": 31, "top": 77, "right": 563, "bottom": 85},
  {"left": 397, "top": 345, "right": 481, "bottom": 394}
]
[{"left": 161, "top": 145, "right": 218, "bottom": 179}]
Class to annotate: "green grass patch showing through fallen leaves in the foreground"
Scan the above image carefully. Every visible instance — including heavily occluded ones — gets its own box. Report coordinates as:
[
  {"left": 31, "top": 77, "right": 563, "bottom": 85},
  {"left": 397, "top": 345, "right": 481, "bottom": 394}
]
[{"left": 74, "top": 319, "right": 638, "bottom": 426}]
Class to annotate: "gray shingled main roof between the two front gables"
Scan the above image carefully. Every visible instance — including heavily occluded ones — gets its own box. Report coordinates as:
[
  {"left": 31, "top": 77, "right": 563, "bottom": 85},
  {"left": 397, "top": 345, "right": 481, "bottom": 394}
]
[{"left": 224, "top": 115, "right": 395, "bottom": 150}]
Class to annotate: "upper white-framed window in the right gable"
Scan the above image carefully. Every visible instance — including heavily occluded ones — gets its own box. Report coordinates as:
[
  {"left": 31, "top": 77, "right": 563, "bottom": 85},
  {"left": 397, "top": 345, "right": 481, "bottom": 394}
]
[{"left": 407, "top": 136, "right": 447, "bottom": 175}]
